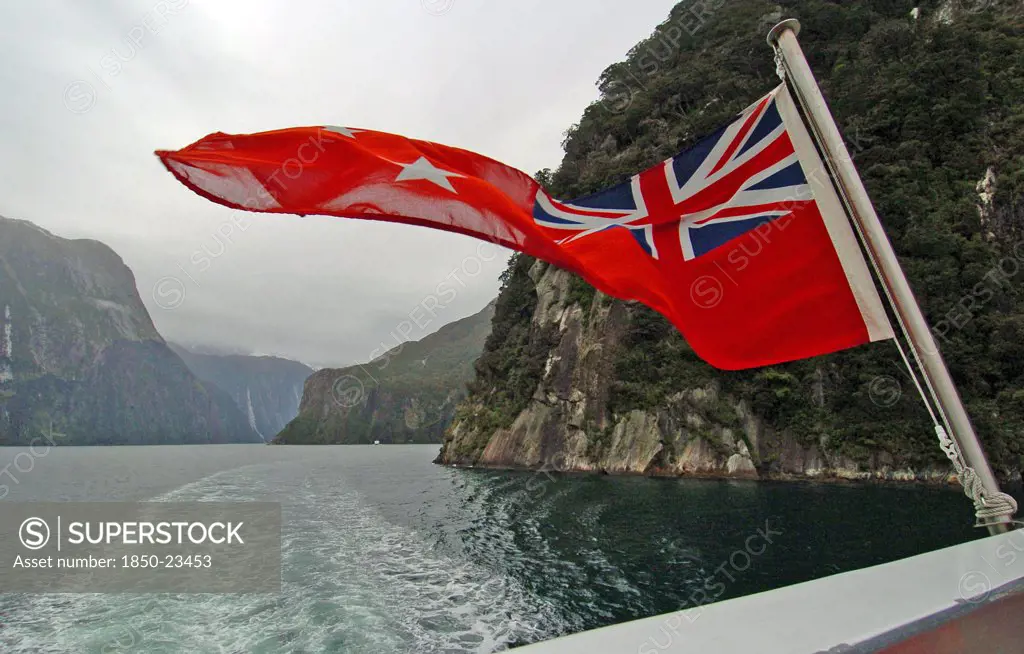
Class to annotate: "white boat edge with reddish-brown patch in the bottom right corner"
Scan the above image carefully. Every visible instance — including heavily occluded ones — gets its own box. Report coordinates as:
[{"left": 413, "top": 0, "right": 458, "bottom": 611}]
[{"left": 516, "top": 531, "right": 1024, "bottom": 654}]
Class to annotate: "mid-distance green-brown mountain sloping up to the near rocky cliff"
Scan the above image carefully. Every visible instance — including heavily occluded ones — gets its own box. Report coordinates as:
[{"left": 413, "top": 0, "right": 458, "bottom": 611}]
[{"left": 274, "top": 303, "right": 494, "bottom": 444}]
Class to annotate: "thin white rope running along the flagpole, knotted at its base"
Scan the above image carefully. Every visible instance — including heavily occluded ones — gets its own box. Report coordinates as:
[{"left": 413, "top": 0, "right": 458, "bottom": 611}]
[{"left": 772, "top": 38, "right": 1018, "bottom": 527}]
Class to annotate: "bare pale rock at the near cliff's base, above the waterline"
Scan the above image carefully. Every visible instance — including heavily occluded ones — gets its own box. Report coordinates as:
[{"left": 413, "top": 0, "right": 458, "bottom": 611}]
[{"left": 437, "top": 257, "right": 948, "bottom": 480}]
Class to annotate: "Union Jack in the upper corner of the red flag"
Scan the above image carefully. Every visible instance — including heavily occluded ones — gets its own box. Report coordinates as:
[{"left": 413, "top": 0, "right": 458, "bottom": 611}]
[{"left": 534, "top": 91, "right": 813, "bottom": 262}]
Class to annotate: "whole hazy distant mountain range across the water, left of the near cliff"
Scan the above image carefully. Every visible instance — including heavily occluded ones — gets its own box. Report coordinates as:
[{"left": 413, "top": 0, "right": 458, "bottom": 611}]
[{"left": 0, "top": 217, "right": 494, "bottom": 445}]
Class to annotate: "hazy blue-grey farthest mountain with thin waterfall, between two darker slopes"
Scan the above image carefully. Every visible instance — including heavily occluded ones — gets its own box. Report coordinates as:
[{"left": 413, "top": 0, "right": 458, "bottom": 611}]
[{"left": 169, "top": 343, "right": 313, "bottom": 440}]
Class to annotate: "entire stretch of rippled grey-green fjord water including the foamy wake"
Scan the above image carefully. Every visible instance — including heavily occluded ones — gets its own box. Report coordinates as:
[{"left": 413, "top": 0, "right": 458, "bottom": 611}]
[{"left": 0, "top": 445, "right": 1007, "bottom": 654}]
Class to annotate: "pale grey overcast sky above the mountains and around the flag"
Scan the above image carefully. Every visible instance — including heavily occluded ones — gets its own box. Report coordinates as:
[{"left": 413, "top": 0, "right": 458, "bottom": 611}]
[{"left": 0, "top": 0, "right": 675, "bottom": 365}]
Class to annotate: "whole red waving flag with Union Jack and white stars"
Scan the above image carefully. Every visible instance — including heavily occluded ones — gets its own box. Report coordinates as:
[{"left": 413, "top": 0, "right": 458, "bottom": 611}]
[{"left": 157, "top": 86, "right": 892, "bottom": 369}]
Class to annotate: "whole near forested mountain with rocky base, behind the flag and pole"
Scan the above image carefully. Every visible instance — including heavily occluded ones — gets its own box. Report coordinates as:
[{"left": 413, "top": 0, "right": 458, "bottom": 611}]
[{"left": 438, "top": 0, "right": 1024, "bottom": 478}]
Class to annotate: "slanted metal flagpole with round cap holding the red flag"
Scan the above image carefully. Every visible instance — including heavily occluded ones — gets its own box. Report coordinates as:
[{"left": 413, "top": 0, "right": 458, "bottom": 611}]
[{"left": 768, "top": 18, "right": 1013, "bottom": 534}]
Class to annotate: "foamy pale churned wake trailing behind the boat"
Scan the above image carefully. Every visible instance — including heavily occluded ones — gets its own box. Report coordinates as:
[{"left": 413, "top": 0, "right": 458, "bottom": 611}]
[{"left": 0, "top": 466, "right": 561, "bottom": 654}]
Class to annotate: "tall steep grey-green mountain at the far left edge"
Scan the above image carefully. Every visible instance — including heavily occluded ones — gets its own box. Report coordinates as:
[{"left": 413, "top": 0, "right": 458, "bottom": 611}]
[{"left": 0, "top": 218, "right": 258, "bottom": 444}]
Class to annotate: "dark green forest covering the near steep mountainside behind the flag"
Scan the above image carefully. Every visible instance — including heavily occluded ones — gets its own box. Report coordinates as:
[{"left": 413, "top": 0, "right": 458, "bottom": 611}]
[{"left": 452, "top": 0, "right": 1024, "bottom": 472}]
